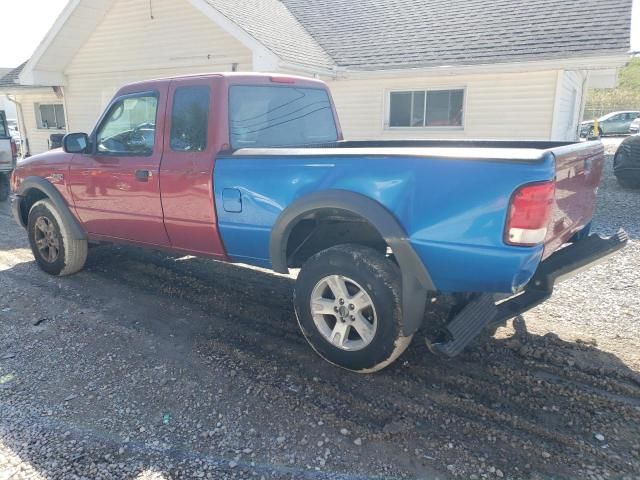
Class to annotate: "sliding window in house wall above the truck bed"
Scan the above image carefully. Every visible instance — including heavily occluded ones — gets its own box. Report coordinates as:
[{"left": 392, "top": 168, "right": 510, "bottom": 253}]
[{"left": 389, "top": 89, "right": 464, "bottom": 128}]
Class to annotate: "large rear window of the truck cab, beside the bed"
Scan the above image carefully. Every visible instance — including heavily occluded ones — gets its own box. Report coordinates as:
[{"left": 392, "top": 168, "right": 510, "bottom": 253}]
[{"left": 229, "top": 85, "right": 338, "bottom": 149}]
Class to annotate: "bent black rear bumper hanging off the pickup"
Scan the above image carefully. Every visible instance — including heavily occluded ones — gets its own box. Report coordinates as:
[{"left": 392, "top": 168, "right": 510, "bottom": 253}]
[{"left": 429, "top": 230, "right": 629, "bottom": 357}]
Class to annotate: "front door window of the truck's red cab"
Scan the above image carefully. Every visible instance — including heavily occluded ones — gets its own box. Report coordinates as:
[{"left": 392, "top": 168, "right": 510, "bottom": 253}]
[{"left": 96, "top": 94, "right": 158, "bottom": 156}]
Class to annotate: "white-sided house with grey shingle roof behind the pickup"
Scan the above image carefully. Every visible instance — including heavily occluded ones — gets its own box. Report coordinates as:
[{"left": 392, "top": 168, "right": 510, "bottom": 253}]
[{"left": 0, "top": 0, "right": 640, "bottom": 154}]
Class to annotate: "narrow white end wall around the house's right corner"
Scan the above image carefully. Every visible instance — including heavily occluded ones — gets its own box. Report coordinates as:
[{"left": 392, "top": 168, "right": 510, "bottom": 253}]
[{"left": 551, "top": 71, "right": 584, "bottom": 140}]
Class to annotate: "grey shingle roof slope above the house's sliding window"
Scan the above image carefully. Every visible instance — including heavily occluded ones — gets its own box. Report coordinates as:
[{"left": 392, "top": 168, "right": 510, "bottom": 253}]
[{"left": 268, "top": 0, "right": 632, "bottom": 70}]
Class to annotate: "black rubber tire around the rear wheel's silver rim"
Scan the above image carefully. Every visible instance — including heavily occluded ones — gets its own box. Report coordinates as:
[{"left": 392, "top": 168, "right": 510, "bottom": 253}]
[{"left": 294, "top": 245, "right": 412, "bottom": 373}]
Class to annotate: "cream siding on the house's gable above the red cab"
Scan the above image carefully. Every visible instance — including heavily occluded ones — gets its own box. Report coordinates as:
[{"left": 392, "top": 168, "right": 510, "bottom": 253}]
[{"left": 65, "top": 0, "right": 252, "bottom": 131}]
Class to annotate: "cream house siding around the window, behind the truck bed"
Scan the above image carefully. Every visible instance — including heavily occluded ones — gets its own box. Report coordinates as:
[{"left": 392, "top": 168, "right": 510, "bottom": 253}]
[{"left": 329, "top": 71, "right": 557, "bottom": 140}]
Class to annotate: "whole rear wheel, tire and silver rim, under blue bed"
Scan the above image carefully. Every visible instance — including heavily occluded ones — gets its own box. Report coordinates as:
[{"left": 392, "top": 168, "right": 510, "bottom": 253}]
[{"left": 294, "top": 245, "right": 412, "bottom": 373}]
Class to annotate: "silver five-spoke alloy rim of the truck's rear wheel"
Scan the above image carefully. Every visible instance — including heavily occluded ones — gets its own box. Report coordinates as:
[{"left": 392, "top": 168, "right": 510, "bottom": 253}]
[{"left": 310, "top": 275, "right": 378, "bottom": 352}]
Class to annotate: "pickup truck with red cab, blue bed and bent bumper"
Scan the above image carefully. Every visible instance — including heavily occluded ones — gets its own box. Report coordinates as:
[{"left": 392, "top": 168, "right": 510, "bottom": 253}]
[{"left": 12, "top": 73, "right": 627, "bottom": 372}]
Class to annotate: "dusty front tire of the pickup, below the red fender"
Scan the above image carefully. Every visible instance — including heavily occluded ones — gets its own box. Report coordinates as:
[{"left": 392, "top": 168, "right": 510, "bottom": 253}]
[{"left": 27, "top": 199, "right": 88, "bottom": 276}]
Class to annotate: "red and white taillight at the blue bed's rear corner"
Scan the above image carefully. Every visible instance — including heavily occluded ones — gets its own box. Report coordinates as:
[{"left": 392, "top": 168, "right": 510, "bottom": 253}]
[{"left": 504, "top": 182, "right": 556, "bottom": 246}]
